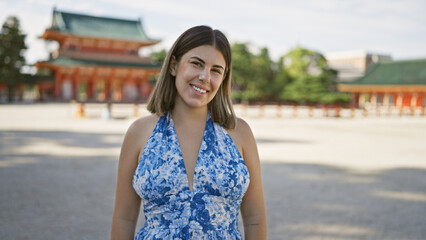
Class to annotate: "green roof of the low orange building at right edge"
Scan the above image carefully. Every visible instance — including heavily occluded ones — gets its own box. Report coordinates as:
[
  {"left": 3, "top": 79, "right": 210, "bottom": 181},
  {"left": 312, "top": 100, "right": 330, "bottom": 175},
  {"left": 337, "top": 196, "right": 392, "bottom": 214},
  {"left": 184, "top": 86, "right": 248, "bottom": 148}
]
[{"left": 345, "top": 59, "right": 426, "bottom": 85}]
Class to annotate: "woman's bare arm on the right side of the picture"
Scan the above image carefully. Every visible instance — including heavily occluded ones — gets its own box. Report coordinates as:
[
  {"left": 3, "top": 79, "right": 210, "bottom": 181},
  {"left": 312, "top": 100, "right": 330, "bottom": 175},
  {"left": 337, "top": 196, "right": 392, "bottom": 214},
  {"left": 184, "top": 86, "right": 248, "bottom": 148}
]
[{"left": 231, "top": 119, "right": 267, "bottom": 240}]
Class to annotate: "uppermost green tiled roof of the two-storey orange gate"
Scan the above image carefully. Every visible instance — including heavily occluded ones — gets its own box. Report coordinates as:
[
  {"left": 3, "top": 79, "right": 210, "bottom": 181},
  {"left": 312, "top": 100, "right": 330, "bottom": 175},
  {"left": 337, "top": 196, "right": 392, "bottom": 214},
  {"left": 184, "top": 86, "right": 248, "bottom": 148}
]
[{"left": 52, "top": 9, "right": 158, "bottom": 42}]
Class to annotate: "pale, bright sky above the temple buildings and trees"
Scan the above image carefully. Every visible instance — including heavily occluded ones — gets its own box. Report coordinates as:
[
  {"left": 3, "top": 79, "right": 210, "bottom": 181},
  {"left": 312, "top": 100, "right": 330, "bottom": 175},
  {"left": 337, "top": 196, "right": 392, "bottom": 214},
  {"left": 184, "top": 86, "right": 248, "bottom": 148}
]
[{"left": 0, "top": 0, "right": 426, "bottom": 64}]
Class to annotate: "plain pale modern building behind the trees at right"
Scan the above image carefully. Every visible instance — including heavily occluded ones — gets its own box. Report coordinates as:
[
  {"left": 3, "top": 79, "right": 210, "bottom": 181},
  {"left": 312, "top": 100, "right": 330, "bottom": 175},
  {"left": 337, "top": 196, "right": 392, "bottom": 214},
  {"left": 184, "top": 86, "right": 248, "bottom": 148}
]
[{"left": 325, "top": 50, "right": 392, "bottom": 82}]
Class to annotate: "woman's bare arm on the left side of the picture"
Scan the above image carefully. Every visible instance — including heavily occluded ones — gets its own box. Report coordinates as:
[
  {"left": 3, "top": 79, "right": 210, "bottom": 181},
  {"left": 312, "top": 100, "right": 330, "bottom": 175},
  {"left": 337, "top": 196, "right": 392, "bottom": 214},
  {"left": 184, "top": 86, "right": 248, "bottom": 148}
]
[{"left": 111, "top": 117, "right": 156, "bottom": 240}]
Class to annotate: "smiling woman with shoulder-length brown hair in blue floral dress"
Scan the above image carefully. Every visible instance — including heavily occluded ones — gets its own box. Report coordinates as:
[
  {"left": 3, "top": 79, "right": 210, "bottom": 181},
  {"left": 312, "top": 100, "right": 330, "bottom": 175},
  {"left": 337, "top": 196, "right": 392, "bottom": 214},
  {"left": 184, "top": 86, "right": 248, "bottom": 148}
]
[{"left": 111, "top": 26, "right": 266, "bottom": 240}]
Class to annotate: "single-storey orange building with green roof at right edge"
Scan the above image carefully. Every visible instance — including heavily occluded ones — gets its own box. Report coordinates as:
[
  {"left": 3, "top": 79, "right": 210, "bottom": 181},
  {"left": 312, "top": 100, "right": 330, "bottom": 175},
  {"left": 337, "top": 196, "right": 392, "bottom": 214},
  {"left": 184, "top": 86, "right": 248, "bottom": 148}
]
[{"left": 337, "top": 59, "right": 426, "bottom": 110}]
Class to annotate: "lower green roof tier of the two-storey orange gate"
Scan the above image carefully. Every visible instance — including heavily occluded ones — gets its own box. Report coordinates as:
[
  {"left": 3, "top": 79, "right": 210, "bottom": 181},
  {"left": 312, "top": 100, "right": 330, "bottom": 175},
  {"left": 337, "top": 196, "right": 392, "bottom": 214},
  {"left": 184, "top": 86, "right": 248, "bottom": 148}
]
[{"left": 46, "top": 57, "right": 161, "bottom": 69}]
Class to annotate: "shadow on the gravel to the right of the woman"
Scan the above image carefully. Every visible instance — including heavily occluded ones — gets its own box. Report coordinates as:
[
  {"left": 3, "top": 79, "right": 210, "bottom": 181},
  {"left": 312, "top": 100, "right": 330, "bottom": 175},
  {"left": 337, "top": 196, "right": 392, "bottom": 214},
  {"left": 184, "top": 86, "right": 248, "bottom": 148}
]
[{"left": 262, "top": 163, "right": 426, "bottom": 240}]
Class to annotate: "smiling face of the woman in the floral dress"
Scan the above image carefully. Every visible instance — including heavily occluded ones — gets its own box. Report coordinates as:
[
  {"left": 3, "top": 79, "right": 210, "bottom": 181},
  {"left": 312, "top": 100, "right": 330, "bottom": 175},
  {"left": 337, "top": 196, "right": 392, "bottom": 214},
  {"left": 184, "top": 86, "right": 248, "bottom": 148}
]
[{"left": 170, "top": 45, "right": 226, "bottom": 108}]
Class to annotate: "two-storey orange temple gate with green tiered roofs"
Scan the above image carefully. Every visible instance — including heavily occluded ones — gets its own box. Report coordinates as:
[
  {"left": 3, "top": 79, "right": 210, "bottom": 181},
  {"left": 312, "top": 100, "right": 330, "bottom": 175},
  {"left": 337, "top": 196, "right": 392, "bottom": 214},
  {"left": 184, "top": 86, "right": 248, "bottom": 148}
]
[{"left": 35, "top": 9, "right": 160, "bottom": 102}]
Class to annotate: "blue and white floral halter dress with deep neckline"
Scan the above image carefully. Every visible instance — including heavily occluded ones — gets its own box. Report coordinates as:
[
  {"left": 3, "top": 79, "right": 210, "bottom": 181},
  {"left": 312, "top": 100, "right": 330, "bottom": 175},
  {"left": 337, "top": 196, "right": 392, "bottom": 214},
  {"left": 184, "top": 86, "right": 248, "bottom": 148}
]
[{"left": 133, "top": 113, "right": 250, "bottom": 240}]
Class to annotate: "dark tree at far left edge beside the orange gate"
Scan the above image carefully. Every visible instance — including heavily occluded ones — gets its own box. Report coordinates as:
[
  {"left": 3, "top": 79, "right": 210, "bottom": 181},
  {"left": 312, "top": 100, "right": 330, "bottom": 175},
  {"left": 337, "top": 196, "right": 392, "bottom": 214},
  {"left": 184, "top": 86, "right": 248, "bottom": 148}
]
[{"left": 0, "top": 16, "right": 27, "bottom": 102}]
